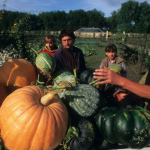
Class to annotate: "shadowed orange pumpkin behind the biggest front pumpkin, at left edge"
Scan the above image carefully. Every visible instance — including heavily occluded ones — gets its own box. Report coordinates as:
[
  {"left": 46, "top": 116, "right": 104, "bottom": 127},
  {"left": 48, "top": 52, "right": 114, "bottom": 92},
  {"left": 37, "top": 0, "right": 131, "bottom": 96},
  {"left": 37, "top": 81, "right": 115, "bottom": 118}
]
[{"left": 0, "top": 59, "right": 37, "bottom": 93}]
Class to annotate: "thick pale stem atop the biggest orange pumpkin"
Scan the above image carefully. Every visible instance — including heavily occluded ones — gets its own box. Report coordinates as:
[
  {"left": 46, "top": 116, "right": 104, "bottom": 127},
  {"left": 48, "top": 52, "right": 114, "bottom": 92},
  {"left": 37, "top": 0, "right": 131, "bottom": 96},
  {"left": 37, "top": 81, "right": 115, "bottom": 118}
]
[{"left": 41, "top": 89, "right": 63, "bottom": 106}]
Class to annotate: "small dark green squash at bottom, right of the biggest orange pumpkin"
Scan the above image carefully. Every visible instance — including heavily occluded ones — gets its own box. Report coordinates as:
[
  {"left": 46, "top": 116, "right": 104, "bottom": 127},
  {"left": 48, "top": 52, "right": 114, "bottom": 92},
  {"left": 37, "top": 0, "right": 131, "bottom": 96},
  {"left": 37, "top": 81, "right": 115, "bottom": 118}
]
[{"left": 69, "top": 118, "right": 95, "bottom": 150}]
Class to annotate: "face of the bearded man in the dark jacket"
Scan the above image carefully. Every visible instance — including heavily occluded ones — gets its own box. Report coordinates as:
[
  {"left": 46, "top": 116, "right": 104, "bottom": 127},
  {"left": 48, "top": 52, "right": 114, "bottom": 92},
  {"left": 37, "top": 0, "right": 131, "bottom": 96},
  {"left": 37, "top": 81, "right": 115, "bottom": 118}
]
[{"left": 61, "top": 36, "right": 74, "bottom": 49}]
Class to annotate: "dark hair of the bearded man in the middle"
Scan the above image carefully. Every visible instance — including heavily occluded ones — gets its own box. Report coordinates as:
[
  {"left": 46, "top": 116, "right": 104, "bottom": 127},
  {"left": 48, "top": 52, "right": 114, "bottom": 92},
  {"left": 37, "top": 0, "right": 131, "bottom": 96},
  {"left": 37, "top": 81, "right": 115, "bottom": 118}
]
[{"left": 59, "top": 28, "right": 76, "bottom": 40}]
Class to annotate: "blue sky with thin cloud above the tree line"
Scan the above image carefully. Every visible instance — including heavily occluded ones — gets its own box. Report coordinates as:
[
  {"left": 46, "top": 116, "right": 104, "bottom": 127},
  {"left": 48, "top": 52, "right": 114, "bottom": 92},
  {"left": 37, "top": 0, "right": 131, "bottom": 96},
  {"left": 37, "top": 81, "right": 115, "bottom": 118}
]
[{"left": 0, "top": 0, "right": 150, "bottom": 17}]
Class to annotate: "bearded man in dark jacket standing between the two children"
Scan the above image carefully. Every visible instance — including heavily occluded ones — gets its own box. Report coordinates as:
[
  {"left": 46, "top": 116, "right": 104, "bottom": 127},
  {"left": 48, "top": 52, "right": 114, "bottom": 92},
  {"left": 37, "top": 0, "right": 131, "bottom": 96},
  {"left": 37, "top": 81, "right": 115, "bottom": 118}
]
[{"left": 53, "top": 29, "right": 86, "bottom": 77}]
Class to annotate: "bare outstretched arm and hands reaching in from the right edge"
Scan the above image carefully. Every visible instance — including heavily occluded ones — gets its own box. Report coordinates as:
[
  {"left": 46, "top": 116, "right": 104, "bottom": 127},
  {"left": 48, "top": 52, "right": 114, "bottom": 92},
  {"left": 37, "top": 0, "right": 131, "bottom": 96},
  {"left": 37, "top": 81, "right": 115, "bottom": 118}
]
[{"left": 93, "top": 66, "right": 150, "bottom": 100}]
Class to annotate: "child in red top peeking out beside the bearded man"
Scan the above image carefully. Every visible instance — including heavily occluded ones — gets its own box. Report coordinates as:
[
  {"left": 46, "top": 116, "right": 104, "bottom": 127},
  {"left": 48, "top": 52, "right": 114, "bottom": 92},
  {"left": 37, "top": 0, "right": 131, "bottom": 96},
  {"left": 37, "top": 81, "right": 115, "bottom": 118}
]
[{"left": 39, "top": 35, "right": 58, "bottom": 56}]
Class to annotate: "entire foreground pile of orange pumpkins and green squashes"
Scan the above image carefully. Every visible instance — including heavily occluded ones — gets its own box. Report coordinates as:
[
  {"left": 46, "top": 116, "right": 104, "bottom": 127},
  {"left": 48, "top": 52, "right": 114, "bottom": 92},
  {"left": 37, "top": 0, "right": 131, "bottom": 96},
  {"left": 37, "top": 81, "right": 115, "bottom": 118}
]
[{"left": 0, "top": 53, "right": 150, "bottom": 150}]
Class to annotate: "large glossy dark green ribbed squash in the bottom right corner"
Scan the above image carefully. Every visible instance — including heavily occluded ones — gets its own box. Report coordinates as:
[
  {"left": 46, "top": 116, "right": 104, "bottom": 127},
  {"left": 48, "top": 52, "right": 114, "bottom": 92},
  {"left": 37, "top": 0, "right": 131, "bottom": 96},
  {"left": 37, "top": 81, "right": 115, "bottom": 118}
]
[{"left": 95, "top": 106, "right": 150, "bottom": 149}]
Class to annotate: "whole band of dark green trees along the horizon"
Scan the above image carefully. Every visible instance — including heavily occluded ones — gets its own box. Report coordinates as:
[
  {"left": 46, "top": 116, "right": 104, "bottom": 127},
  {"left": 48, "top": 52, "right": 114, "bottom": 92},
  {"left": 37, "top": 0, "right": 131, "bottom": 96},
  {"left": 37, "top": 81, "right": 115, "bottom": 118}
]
[{"left": 0, "top": 0, "right": 150, "bottom": 33}]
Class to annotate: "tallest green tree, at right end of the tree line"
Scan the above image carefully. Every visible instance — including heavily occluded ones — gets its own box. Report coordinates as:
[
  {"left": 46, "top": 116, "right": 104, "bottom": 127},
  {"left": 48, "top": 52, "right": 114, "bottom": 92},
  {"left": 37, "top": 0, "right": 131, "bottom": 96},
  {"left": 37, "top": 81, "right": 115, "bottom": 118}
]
[{"left": 117, "top": 0, "right": 150, "bottom": 33}]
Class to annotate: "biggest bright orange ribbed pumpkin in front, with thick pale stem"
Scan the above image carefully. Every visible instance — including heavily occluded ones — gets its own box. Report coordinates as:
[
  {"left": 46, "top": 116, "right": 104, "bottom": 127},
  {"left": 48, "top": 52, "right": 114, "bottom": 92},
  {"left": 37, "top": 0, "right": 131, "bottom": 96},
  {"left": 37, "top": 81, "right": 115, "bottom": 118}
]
[{"left": 0, "top": 86, "right": 68, "bottom": 150}]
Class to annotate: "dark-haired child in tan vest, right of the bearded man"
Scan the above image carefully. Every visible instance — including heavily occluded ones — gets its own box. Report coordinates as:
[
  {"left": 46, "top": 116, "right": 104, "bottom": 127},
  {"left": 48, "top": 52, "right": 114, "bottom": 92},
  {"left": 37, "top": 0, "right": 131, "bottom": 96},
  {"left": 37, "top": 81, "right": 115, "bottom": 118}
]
[{"left": 99, "top": 44, "right": 127, "bottom": 77}]
